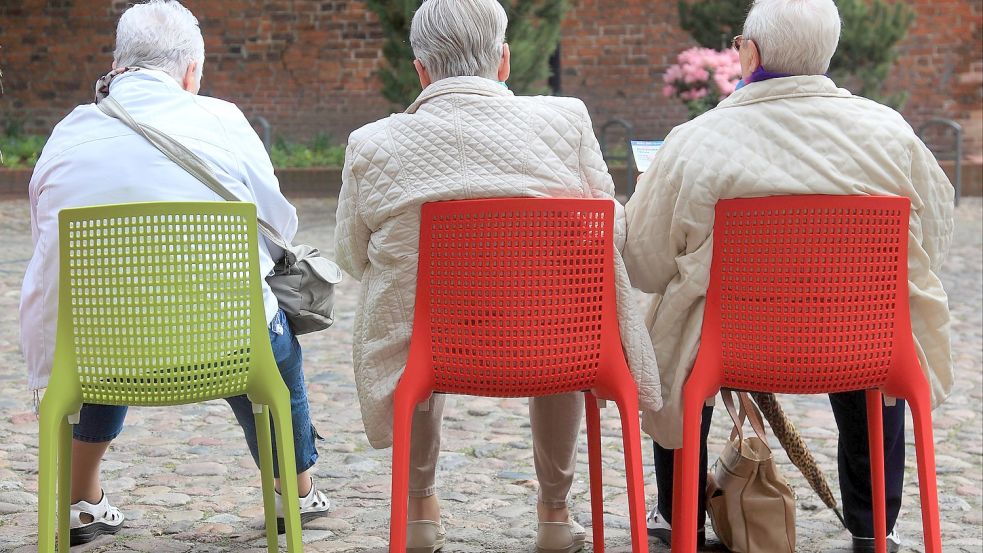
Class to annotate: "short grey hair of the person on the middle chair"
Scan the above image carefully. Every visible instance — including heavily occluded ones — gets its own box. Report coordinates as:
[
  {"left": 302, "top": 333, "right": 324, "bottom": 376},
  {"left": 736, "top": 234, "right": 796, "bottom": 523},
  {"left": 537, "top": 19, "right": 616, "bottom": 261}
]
[{"left": 410, "top": 0, "right": 508, "bottom": 81}]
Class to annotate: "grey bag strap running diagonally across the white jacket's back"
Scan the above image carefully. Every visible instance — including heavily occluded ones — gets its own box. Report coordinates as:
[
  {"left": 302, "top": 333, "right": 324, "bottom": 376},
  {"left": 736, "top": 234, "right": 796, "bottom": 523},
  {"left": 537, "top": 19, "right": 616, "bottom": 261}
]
[{"left": 96, "top": 96, "right": 290, "bottom": 251}]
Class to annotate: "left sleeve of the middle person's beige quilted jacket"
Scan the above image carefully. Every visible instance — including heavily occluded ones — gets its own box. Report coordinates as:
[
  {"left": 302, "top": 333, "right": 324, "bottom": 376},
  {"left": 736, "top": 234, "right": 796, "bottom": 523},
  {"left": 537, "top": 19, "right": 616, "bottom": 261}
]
[{"left": 335, "top": 141, "right": 372, "bottom": 280}]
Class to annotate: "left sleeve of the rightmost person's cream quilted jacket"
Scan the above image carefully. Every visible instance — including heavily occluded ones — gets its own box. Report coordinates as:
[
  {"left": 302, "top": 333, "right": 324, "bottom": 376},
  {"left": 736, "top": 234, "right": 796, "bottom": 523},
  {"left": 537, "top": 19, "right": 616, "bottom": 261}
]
[{"left": 623, "top": 146, "right": 686, "bottom": 295}]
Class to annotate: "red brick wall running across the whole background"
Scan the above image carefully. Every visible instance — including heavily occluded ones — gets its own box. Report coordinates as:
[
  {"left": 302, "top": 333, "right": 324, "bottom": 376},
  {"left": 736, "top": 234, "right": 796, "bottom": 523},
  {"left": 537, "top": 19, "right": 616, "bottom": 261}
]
[{"left": 0, "top": 0, "right": 983, "bottom": 157}]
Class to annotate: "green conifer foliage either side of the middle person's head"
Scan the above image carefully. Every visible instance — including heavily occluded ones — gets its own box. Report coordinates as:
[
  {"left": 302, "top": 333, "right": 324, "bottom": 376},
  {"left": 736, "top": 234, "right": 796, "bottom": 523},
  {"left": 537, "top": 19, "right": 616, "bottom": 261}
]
[{"left": 368, "top": 0, "right": 569, "bottom": 106}]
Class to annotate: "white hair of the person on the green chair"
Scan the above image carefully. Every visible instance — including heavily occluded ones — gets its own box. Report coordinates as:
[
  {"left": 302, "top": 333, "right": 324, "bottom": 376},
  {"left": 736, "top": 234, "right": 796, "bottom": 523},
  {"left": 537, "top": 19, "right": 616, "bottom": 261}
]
[{"left": 113, "top": 0, "right": 205, "bottom": 83}]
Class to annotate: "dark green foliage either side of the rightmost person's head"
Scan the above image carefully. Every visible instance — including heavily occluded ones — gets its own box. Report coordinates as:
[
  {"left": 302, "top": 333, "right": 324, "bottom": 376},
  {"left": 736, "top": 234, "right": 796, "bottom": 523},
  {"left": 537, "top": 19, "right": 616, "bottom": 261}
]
[{"left": 679, "top": 0, "right": 915, "bottom": 108}]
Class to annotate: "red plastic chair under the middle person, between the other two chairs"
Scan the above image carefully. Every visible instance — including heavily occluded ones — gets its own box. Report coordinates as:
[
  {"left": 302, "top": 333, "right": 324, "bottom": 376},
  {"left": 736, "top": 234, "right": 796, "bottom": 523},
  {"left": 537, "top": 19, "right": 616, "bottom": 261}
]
[{"left": 389, "top": 198, "right": 648, "bottom": 553}]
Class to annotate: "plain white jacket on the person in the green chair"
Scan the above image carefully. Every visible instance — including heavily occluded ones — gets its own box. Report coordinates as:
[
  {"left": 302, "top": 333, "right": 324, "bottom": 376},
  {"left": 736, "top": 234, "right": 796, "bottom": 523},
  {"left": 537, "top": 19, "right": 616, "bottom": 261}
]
[{"left": 20, "top": 69, "right": 297, "bottom": 390}]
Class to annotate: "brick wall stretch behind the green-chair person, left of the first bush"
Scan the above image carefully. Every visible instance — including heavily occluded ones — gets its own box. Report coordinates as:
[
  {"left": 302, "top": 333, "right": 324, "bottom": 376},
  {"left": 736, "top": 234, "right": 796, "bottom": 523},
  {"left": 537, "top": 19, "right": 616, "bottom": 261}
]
[{"left": 0, "top": 0, "right": 390, "bottom": 144}]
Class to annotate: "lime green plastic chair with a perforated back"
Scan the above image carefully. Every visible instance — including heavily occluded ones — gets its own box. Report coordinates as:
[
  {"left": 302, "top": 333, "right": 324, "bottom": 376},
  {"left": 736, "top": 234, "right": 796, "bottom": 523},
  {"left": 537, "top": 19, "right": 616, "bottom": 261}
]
[{"left": 38, "top": 202, "right": 303, "bottom": 553}]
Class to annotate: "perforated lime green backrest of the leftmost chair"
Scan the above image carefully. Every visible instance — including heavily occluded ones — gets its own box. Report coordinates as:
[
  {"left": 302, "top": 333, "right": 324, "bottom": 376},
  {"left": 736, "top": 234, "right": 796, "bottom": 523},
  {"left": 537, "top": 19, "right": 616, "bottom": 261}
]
[{"left": 58, "top": 202, "right": 268, "bottom": 405}]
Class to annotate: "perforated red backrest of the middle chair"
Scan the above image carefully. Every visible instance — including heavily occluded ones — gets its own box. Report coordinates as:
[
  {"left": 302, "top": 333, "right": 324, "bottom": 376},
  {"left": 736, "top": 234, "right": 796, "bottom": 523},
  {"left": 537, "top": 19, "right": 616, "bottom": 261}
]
[{"left": 414, "top": 198, "right": 621, "bottom": 397}]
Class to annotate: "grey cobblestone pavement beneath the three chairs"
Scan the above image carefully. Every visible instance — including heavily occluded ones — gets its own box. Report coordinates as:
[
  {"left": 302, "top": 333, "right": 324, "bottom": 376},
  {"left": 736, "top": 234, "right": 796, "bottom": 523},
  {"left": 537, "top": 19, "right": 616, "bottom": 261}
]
[{"left": 0, "top": 198, "right": 983, "bottom": 553}]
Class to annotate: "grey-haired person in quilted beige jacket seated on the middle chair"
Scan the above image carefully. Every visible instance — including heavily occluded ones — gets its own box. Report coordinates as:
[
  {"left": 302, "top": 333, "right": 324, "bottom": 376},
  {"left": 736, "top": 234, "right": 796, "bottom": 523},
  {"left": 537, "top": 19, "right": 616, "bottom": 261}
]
[{"left": 335, "top": 0, "right": 660, "bottom": 553}]
